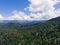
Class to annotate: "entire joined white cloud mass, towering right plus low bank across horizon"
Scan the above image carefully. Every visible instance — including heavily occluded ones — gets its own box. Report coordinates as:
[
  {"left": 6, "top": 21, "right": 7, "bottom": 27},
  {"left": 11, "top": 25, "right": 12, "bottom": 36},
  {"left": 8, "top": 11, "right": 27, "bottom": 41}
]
[{"left": 0, "top": 0, "right": 60, "bottom": 20}]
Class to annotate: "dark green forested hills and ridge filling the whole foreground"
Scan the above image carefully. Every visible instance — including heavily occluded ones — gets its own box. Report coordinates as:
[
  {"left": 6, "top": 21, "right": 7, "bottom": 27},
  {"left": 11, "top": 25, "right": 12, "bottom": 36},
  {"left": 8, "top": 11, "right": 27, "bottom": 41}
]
[{"left": 0, "top": 17, "right": 60, "bottom": 45}]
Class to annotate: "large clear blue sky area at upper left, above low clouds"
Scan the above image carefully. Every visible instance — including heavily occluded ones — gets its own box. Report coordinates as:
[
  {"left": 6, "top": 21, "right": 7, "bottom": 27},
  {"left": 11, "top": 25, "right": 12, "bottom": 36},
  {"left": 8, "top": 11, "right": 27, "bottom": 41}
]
[{"left": 0, "top": 0, "right": 29, "bottom": 17}]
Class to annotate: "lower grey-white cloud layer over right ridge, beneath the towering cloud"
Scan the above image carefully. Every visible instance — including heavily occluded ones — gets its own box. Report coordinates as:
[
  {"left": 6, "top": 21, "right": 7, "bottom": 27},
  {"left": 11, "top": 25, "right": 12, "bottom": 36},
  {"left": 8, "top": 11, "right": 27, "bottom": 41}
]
[{"left": 30, "top": 10, "right": 60, "bottom": 20}]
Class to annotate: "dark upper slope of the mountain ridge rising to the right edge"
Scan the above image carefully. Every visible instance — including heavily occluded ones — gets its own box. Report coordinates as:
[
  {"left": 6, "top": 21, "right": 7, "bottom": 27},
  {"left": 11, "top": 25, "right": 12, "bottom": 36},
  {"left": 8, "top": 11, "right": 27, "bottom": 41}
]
[{"left": 22, "top": 17, "right": 60, "bottom": 30}]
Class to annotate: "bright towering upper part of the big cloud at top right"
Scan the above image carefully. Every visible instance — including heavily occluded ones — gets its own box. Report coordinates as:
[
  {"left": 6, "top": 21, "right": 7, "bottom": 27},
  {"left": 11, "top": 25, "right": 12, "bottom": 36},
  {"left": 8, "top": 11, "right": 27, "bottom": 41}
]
[{"left": 27, "top": 0, "right": 60, "bottom": 12}]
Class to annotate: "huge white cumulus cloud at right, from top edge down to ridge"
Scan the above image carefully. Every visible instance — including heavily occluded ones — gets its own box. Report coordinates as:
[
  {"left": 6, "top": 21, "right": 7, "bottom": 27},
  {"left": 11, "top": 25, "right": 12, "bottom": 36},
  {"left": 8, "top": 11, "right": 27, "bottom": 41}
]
[{"left": 25, "top": 0, "right": 60, "bottom": 20}]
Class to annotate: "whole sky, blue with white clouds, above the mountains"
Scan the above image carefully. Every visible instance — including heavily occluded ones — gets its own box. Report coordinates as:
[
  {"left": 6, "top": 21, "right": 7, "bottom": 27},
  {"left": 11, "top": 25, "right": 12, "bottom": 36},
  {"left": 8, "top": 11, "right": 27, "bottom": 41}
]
[{"left": 0, "top": 0, "right": 60, "bottom": 20}]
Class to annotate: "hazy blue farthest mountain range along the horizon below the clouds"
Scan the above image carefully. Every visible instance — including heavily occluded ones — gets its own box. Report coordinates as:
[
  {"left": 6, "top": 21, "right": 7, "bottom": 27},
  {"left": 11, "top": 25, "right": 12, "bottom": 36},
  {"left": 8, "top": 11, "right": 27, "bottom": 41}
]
[{"left": 0, "top": 20, "right": 46, "bottom": 25}]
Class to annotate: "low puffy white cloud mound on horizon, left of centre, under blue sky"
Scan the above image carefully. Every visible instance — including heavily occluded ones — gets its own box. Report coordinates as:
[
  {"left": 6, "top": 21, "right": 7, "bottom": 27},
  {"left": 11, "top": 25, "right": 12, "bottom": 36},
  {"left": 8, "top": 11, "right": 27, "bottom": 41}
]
[{"left": 8, "top": 11, "right": 31, "bottom": 20}]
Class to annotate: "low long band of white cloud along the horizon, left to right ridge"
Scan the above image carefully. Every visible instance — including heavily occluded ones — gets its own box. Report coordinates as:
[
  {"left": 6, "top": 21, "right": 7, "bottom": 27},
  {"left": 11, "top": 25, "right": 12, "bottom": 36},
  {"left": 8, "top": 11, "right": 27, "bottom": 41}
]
[{"left": 8, "top": 10, "right": 60, "bottom": 20}]
